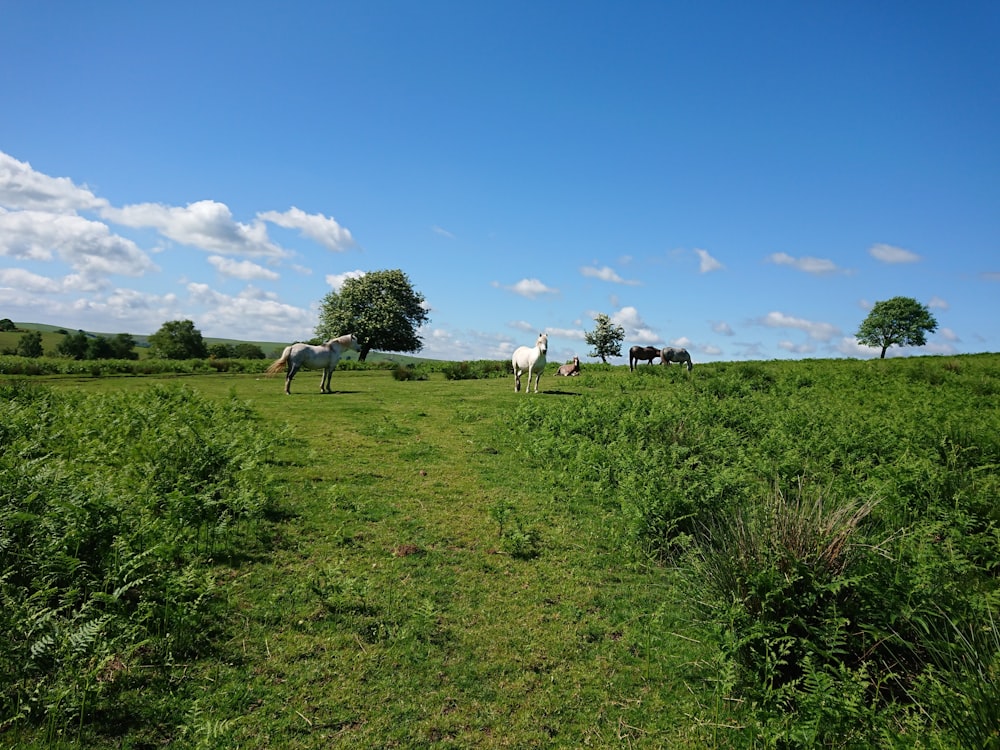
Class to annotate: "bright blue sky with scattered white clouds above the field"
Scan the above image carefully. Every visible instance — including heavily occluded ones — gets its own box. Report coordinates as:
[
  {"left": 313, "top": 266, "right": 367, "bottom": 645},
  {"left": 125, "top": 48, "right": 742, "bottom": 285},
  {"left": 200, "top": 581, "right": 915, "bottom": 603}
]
[{"left": 0, "top": 0, "right": 1000, "bottom": 363}]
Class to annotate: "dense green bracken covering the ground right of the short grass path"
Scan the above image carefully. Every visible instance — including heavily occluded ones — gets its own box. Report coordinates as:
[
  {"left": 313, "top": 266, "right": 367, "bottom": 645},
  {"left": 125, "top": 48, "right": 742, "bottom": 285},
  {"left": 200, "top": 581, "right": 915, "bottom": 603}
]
[{"left": 500, "top": 357, "right": 1000, "bottom": 748}]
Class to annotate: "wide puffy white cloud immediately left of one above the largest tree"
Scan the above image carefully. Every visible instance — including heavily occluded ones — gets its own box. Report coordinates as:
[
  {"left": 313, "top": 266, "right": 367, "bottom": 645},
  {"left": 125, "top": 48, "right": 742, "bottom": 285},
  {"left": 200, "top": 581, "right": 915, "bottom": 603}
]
[{"left": 101, "top": 200, "right": 289, "bottom": 258}]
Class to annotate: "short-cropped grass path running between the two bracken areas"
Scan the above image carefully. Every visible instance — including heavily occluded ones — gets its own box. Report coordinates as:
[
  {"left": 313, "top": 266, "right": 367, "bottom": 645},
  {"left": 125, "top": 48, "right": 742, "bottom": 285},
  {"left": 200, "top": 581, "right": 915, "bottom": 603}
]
[{"left": 56, "top": 371, "right": 712, "bottom": 748}]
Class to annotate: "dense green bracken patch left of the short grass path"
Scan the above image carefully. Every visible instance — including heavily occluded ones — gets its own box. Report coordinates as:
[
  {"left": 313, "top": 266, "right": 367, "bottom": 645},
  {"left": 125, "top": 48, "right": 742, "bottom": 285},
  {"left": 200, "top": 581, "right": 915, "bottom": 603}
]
[{"left": 0, "top": 382, "right": 290, "bottom": 738}]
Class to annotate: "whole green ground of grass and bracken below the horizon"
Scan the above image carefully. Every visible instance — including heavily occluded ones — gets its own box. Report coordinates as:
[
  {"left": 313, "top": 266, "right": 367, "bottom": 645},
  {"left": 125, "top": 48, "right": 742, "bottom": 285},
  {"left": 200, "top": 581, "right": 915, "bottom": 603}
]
[{"left": 0, "top": 355, "right": 1000, "bottom": 749}]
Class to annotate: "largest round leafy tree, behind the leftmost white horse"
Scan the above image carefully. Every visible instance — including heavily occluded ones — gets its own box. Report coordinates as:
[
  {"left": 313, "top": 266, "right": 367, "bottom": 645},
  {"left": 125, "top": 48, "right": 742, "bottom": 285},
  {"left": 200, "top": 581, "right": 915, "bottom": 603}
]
[{"left": 316, "top": 269, "right": 429, "bottom": 362}]
